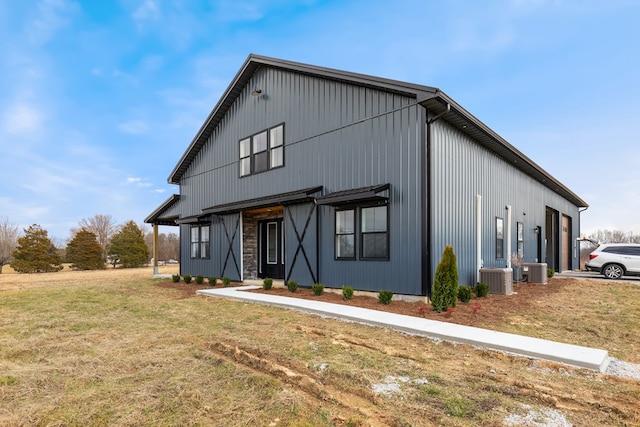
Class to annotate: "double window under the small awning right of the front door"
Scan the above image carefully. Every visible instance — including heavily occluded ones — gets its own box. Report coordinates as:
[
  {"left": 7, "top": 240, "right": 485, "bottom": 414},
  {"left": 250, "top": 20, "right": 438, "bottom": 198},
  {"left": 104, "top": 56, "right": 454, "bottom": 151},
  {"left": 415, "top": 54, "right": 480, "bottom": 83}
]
[{"left": 335, "top": 205, "right": 389, "bottom": 260}]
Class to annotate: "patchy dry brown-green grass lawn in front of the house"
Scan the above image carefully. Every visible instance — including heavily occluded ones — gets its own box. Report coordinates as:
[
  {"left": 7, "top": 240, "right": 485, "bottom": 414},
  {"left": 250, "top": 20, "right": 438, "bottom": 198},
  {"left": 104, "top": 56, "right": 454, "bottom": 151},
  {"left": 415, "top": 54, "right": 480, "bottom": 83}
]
[{"left": 0, "top": 269, "right": 640, "bottom": 426}]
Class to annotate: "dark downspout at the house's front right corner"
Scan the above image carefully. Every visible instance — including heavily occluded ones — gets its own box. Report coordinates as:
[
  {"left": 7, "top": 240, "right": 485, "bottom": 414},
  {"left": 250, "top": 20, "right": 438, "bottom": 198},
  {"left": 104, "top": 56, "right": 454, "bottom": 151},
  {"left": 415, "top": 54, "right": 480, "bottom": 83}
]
[{"left": 421, "top": 103, "right": 451, "bottom": 298}]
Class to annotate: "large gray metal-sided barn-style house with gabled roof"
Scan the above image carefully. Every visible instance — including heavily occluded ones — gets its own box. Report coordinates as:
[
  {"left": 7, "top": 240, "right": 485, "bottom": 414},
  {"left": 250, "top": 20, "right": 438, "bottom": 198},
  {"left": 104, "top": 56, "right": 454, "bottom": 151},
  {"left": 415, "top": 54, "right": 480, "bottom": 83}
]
[{"left": 145, "top": 55, "right": 588, "bottom": 295}]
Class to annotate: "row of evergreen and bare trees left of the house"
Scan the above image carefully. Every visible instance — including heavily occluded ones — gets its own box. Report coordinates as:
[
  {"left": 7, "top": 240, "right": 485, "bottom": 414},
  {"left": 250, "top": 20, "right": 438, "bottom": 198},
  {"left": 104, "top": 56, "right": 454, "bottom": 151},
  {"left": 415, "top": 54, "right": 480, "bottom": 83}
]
[{"left": 0, "top": 215, "right": 180, "bottom": 273}]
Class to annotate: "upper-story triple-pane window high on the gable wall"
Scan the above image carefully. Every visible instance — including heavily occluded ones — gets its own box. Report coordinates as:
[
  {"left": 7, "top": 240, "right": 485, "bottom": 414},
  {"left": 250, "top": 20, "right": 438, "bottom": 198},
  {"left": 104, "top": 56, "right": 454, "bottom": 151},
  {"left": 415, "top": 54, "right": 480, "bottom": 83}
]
[{"left": 240, "top": 125, "right": 284, "bottom": 177}]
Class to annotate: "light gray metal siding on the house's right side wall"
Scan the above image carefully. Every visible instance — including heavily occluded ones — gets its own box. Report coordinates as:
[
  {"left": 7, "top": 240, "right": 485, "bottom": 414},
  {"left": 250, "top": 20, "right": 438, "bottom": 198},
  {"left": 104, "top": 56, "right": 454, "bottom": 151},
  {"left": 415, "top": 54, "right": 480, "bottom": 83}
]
[{"left": 431, "top": 120, "right": 580, "bottom": 285}]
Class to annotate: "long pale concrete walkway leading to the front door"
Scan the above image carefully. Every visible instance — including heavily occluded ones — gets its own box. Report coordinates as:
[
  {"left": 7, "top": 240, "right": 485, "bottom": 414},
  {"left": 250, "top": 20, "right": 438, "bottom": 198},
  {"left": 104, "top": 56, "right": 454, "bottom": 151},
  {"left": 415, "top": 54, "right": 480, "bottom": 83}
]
[{"left": 196, "top": 286, "right": 610, "bottom": 372}]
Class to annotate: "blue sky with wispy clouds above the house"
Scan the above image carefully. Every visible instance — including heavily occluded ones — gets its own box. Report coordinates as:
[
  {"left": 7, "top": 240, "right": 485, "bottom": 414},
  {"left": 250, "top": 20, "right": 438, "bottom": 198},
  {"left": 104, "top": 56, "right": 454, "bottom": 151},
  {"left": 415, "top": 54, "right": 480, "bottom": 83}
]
[{"left": 0, "top": 0, "right": 640, "bottom": 241}]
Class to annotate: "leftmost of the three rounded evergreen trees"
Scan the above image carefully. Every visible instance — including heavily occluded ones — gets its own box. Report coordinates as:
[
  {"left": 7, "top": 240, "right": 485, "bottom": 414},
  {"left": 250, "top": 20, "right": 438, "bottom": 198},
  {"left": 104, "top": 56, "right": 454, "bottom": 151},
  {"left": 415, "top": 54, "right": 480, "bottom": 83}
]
[{"left": 11, "top": 224, "right": 62, "bottom": 273}]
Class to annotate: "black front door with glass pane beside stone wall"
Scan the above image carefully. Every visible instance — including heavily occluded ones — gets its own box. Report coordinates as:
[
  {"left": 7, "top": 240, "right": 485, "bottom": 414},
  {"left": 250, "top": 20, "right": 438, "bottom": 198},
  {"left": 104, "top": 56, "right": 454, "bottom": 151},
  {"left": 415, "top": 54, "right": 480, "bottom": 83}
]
[{"left": 258, "top": 218, "right": 284, "bottom": 279}]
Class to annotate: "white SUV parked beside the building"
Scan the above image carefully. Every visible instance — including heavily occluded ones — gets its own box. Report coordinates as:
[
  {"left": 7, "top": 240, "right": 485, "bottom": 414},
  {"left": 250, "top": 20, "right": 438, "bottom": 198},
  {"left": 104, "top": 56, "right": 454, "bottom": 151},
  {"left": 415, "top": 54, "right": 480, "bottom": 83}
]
[{"left": 585, "top": 243, "right": 640, "bottom": 279}]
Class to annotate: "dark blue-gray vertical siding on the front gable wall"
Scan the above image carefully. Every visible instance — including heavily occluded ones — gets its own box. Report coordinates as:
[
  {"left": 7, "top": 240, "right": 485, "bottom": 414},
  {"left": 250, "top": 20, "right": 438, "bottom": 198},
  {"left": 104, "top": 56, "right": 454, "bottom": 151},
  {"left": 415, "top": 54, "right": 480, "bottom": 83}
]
[{"left": 180, "top": 67, "right": 424, "bottom": 294}]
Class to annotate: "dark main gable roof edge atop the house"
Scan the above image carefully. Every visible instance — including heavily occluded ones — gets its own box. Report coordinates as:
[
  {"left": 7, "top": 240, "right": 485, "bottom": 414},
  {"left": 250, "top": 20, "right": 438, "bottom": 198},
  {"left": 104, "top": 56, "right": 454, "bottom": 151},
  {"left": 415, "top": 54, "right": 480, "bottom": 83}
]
[{"left": 168, "top": 54, "right": 589, "bottom": 207}]
